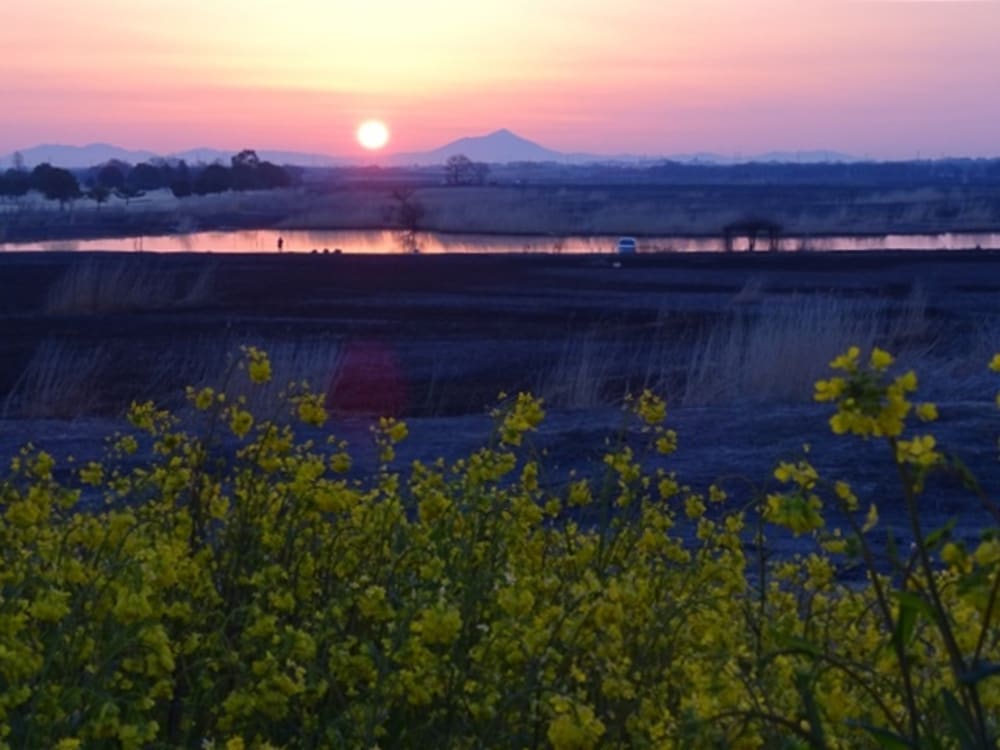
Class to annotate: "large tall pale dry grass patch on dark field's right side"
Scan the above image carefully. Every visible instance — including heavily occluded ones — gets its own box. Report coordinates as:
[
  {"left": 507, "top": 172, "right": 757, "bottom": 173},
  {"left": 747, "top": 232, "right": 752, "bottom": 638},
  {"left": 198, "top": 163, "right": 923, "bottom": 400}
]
[{"left": 535, "top": 284, "right": 936, "bottom": 409}]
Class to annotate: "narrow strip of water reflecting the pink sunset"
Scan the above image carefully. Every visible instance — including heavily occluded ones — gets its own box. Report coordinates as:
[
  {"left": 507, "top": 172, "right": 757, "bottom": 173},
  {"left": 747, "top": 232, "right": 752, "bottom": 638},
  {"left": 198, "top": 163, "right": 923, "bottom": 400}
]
[{"left": 0, "top": 229, "right": 1000, "bottom": 254}]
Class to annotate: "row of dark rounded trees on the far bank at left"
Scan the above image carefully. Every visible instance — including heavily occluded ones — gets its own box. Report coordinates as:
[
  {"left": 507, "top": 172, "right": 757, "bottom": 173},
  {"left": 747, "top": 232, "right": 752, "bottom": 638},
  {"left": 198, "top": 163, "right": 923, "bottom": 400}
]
[{"left": 0, "top": 149, "right": 296, "bottom": 206}]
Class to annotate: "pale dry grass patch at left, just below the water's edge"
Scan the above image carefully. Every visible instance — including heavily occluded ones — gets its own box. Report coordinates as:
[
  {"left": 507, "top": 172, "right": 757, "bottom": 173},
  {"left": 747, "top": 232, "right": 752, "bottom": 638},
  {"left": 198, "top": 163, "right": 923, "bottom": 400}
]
[{"left": 45, "top": 257, "right": 215, "bottom": 315}]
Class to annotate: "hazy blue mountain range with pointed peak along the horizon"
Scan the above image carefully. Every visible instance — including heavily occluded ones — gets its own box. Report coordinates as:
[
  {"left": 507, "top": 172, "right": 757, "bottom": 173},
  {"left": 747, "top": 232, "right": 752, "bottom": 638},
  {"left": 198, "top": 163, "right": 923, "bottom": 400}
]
[{"left": 0, "top": 129, "right": 857, "bottom": 169}]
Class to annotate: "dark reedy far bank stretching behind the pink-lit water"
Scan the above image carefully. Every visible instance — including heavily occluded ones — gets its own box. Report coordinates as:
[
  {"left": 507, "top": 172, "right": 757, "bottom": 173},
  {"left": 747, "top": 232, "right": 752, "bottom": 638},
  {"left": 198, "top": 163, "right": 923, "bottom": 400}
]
[{"left": 0, "top": 183, "right": 1000, "bottom": 243}]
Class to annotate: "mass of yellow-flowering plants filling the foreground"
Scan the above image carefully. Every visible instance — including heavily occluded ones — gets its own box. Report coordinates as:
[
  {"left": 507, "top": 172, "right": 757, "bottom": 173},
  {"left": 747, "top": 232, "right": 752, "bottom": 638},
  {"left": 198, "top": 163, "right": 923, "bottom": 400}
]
[{"left": 0, "top": 348, "right": 1000, "bottom": 748}]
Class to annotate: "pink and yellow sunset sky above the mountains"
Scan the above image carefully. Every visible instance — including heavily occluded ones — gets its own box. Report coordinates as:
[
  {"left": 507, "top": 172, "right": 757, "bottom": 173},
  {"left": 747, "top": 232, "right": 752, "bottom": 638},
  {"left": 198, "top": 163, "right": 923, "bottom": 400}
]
[{"left": 0, "top": 0, "right": 1000, "bottom": 159}]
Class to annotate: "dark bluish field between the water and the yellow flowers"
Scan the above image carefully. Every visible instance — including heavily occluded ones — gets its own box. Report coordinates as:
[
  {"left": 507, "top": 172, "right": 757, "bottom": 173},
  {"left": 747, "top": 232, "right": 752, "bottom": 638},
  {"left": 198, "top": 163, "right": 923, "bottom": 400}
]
[{"left": 0, "top": 252, "right": 1000, "bottom": 560}]
